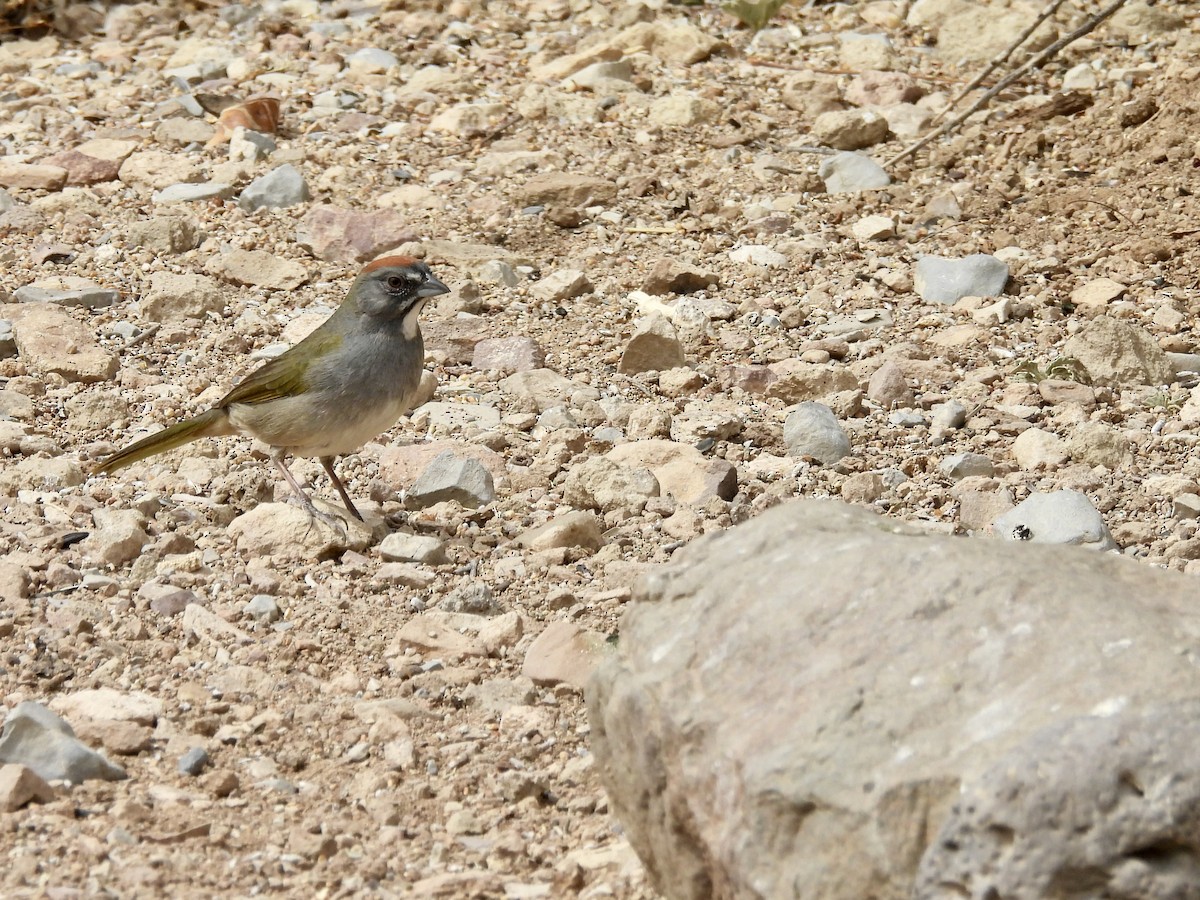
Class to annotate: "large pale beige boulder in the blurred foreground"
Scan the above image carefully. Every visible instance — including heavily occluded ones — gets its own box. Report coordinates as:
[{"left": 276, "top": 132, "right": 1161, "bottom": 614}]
[{"left": 588, "top": 502, "right": 1200, "bottom": 900}]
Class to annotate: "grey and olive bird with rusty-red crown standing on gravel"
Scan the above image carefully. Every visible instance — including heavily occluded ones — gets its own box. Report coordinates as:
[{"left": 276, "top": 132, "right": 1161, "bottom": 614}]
[{"left": 94, "top": 256, "right": 450, "bottom": 522}]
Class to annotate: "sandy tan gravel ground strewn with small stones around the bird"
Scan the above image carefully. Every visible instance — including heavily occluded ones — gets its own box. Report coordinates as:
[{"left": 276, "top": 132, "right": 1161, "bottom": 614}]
[{"left": 0, "top": 0, "right": 1200, "bottom": 898}]
